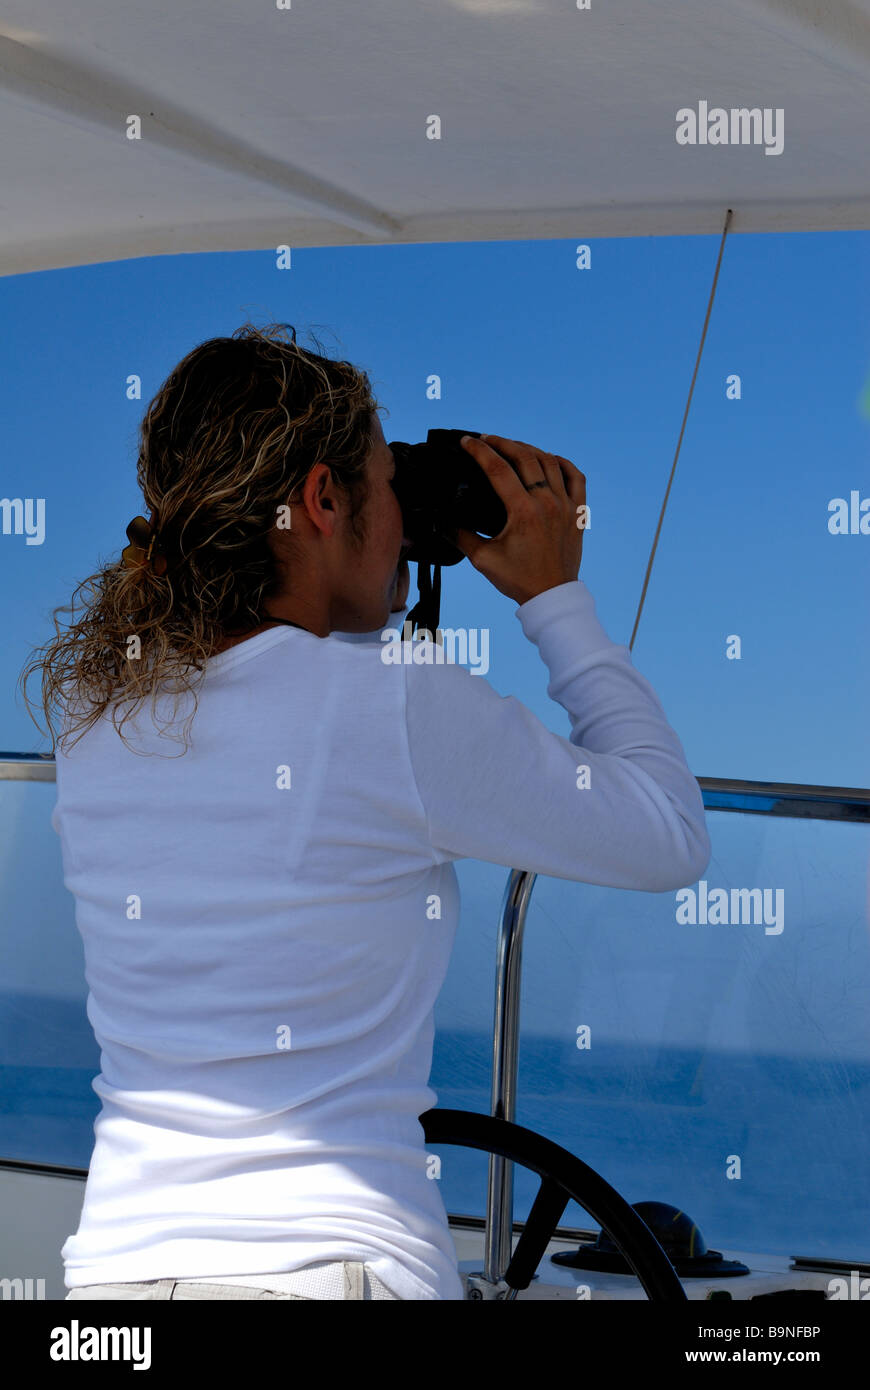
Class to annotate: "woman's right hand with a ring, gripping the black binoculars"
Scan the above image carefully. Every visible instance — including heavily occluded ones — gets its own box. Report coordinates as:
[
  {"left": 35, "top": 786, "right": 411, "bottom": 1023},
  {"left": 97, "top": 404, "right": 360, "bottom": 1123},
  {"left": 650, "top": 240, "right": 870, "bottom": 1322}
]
[{"left": 448, "top": 435, "right": 586, "bottom": 603}]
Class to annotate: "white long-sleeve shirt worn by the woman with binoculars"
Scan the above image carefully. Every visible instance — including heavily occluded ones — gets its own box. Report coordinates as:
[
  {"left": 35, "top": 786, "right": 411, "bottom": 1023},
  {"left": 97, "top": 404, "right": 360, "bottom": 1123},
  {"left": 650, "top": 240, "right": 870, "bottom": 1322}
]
[{"left": 53, "top": 581, "right": 710, "bottom": 1300}]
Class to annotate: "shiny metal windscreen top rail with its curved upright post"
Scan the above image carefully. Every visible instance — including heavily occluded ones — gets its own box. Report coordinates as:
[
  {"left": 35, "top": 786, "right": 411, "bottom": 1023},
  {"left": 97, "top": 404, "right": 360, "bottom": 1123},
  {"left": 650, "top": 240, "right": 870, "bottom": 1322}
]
[{"left": 0, "top": 752, "right": 870, "bottom": 1284}]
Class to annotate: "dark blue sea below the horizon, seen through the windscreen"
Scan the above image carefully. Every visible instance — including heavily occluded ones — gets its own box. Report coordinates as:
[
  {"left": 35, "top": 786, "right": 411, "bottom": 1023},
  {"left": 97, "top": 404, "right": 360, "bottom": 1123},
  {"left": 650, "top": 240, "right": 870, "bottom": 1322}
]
[{"left": 0, "top": 994, "right": 870, "bottom": 1259}]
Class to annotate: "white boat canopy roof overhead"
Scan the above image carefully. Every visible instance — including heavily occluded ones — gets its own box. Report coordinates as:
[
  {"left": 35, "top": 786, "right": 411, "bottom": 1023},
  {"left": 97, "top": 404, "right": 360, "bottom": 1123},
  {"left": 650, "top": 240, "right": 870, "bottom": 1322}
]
[{"left": 0, "top": 0, "right": 870, "bottom": 275}]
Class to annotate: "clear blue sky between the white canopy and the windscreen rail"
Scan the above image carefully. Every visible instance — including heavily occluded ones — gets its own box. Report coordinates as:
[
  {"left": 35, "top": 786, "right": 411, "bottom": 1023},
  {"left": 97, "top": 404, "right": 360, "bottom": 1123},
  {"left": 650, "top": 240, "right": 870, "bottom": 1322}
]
[{"left": 0, "top": 232, "right": 870, "bottom": 785}]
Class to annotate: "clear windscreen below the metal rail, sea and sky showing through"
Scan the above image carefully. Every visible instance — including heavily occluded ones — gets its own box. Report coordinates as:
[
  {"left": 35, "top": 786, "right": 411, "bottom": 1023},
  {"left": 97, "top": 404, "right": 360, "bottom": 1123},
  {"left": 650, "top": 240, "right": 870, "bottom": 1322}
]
[{"left": 0, "top": 783, "right": 870, "bottom": 1259}]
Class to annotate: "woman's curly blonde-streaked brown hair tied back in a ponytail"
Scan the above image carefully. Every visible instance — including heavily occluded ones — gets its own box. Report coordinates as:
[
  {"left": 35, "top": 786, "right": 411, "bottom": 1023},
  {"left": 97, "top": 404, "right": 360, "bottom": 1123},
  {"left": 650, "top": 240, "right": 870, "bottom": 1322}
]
[{"left": 19, "top": 322, "right": 382, "bottom": 752}]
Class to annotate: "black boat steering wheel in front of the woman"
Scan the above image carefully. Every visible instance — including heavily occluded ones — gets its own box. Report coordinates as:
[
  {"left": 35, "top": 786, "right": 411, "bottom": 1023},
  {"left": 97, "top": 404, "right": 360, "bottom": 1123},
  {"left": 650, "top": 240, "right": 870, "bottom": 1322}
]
[{"left": 420, "top": 1109, "right": 687, "bottom": 1302}]
